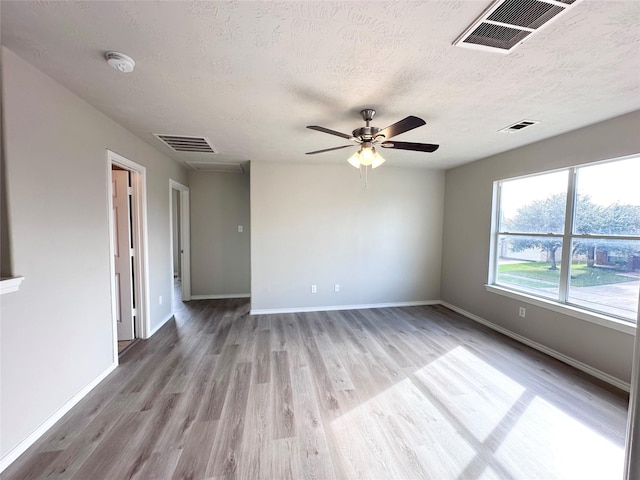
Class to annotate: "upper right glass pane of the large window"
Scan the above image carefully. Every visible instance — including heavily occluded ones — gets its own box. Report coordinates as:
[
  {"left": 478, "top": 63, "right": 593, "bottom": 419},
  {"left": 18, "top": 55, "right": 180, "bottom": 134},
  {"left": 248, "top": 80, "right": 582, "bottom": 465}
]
[{"left": 573, "top": 158, "right": 640, "bottom": 235}]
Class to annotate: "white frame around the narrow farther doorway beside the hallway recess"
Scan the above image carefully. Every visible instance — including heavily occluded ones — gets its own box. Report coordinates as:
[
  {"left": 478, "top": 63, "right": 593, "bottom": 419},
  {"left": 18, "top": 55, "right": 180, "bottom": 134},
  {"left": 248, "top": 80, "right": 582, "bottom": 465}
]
[{"left": 169, "top": 179, "right": 191, "bottom": 305}]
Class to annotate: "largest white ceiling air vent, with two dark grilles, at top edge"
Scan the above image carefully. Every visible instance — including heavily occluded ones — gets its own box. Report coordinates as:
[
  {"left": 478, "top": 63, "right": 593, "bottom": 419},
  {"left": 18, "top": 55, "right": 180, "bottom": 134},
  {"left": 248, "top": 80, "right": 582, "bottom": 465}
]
[{"left": 453, "top": 0, "right": 581, "bottom": 53}]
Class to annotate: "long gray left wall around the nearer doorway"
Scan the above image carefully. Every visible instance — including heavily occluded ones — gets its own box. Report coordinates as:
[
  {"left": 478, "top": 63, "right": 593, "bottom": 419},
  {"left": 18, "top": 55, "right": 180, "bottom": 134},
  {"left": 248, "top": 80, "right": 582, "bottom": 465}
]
[{"left": 0, "top": 48, "right": 188, "bottom": 462}]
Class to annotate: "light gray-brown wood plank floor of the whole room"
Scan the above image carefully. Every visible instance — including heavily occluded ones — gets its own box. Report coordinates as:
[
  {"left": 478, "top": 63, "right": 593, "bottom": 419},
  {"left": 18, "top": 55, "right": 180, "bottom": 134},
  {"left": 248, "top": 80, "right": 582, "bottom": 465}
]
[{"left": 2, "top": 300, "right": 628, "bottom": 480}]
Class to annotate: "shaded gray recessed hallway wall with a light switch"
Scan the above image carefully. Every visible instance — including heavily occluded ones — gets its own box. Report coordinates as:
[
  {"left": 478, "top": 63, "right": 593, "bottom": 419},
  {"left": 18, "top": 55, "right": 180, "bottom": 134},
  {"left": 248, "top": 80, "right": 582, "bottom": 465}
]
[{"left": 189, "top": 172, "right": 251, "bottom": 296}]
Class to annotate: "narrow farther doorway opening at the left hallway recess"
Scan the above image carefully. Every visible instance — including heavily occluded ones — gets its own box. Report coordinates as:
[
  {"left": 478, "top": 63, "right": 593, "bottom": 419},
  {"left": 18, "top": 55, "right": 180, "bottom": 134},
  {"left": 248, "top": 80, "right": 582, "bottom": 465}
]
[{"left": 169, "top": 180, "right": 191, "bottom": 313}]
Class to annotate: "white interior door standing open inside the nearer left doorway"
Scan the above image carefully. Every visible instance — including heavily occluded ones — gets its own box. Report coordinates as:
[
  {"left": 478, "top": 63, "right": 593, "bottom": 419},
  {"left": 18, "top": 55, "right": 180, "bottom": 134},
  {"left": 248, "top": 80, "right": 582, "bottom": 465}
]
[{"left": 111, "top": 170, "right": 135, "bottom": 340}]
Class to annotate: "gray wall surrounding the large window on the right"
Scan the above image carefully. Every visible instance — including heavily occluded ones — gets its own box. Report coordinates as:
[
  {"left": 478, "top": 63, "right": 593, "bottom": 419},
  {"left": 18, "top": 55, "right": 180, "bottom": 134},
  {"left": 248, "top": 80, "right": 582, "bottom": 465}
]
[{"left": 442, "top": 112, "right": 640, "bottom": 382}]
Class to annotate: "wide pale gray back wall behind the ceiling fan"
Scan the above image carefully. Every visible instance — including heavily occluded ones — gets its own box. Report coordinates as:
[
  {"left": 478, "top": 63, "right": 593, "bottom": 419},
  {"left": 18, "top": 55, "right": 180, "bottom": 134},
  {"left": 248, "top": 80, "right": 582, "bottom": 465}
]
[{"left": 251, "top": 162, "right": 444, "bottom": 310}]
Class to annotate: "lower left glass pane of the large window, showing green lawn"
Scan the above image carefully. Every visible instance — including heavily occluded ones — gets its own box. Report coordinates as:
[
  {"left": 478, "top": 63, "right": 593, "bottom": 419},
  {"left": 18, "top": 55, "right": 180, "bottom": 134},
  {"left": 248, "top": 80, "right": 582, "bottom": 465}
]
[{"left": 496, "top": 235, "right": 562, "bottom": 300}]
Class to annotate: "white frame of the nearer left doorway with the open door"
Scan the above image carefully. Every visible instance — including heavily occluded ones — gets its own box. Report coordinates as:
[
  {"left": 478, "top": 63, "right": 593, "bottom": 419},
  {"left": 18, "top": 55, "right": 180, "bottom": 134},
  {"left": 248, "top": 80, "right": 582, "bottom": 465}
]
[{"left": 107, "top": 150, "right": 151, "bottom": 365}]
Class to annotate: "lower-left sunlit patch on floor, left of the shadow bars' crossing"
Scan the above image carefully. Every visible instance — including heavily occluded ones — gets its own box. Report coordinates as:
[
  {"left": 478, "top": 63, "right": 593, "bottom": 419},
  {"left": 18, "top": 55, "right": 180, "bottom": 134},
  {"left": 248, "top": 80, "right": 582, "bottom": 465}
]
[{"left": 331, "top": 379, "right": 475, "bottom": 479}]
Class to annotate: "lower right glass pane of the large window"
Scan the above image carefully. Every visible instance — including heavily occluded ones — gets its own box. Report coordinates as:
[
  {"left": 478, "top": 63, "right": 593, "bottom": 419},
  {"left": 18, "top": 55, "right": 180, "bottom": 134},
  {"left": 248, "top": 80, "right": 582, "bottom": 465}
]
[{"left": 568, "top": 239, "right": 640, "bottom": 321}]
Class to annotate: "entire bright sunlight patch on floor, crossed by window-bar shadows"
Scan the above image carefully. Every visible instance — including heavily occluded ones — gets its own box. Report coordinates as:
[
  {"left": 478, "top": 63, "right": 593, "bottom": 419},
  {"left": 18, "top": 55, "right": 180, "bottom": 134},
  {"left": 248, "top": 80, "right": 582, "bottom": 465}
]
[{"left": 331, "top": 346, "right": 624, "bottom": 480}]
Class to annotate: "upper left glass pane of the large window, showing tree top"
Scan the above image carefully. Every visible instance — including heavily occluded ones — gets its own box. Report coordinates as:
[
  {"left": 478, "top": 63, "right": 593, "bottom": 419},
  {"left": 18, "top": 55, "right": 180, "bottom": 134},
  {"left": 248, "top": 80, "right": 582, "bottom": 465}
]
[{"left": 499, "top": 170, "right": 568, "bottom": 233}]
